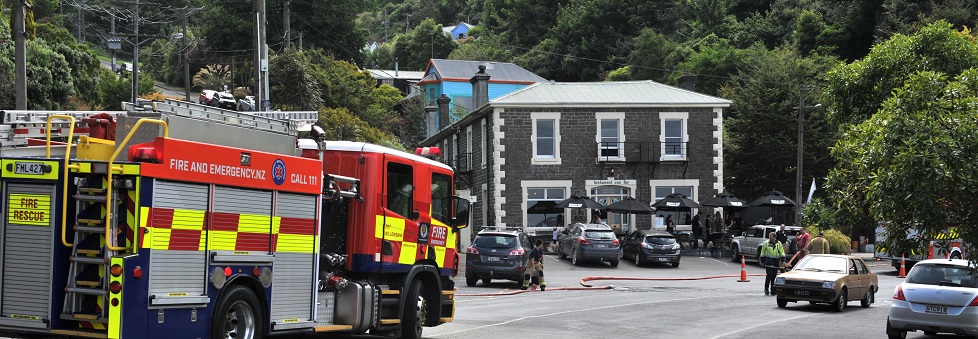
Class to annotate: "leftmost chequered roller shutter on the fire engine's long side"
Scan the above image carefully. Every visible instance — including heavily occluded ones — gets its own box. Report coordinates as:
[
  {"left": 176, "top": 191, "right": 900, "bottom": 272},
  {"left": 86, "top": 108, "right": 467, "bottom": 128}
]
[{"left": 143, "top": 179, "right": 210, "bottom": 298}]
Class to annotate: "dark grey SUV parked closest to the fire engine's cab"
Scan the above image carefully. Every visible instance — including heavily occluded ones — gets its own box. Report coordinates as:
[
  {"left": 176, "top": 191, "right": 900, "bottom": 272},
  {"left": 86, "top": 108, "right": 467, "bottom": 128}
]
[{"left": 465, "top": 228, "right": 533, "bottom": 286}]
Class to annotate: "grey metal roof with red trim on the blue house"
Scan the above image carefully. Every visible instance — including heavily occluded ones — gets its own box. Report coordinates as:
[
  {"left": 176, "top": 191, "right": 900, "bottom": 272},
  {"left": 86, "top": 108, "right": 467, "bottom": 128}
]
[{"left": 429, "top": 59, "right": 547, "bottom": 83}]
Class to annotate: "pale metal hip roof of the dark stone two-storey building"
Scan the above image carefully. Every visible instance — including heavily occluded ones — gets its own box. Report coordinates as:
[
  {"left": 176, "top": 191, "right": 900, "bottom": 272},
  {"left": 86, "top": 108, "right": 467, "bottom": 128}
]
[{"left": 489, "top": 80, "right": 731, "bottom": 107}]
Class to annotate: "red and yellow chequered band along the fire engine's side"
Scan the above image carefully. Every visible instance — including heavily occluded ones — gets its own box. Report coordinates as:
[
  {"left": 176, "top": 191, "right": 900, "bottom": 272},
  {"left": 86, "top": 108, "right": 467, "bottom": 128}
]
[{"left": 139, "top": 207, "right": 318, "bottom": 253}]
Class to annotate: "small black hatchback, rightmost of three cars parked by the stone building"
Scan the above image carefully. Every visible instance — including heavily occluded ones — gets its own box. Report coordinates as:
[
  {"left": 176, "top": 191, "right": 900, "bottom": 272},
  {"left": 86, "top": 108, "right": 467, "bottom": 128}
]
[{"left": 621, "top": 230, "right": 682, "bottom": 267}]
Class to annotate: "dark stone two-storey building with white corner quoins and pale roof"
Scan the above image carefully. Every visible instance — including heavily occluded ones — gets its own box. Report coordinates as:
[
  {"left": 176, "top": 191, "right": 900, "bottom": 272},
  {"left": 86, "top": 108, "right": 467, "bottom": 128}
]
[{"left": 422, "top": 73, "right": 731, "bottom": 247}]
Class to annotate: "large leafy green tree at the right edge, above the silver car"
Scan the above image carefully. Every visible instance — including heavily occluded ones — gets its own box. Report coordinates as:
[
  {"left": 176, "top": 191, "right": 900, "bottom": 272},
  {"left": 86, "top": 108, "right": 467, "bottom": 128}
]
[{"left": 830, "top": 69, "right": 978, "bottom": 262}]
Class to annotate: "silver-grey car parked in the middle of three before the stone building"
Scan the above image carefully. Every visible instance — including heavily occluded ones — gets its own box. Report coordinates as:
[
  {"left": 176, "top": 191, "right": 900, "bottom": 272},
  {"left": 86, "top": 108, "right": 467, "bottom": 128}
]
[{"left": 557, "top": 223, "right": 621, "bottom": 267}]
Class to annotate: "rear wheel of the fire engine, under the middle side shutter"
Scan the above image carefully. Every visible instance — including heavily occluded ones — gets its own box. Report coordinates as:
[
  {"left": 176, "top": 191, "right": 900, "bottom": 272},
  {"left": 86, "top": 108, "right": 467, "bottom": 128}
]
[{"left": 211, "top": 285, "right": 265, "bottom": 339}]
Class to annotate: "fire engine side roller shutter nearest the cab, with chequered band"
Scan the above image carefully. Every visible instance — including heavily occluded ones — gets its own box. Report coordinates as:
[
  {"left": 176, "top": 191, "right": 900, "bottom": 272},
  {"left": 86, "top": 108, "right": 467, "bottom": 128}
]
[{"left": 270, "top": 192, "right": 319, "bottom": 329}]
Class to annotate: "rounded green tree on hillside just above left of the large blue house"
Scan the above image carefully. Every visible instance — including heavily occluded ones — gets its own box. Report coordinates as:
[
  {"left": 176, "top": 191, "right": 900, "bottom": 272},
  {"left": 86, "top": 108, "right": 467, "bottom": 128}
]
[{"left": 394, "top": 19, "right": 455, "bottom": 70}]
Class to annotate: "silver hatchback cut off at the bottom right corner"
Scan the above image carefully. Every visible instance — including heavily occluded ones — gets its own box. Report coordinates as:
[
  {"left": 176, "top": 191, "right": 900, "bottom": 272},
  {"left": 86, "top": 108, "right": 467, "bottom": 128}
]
[{"left": 886, "top": 259, "right": 978, "bottom": 339}]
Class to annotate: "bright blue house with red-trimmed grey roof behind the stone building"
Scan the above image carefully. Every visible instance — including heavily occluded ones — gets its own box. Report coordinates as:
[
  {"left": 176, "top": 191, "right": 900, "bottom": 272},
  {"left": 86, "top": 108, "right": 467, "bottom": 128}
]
[{"left": 418, "top": 59, "right": 547, "bottom": 136}]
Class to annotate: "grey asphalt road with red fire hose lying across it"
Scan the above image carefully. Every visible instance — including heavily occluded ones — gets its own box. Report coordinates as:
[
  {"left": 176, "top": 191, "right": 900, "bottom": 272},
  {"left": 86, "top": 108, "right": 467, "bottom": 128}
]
[{"left": 425, "top": 255, "right": 936, "bottom": 339}]
